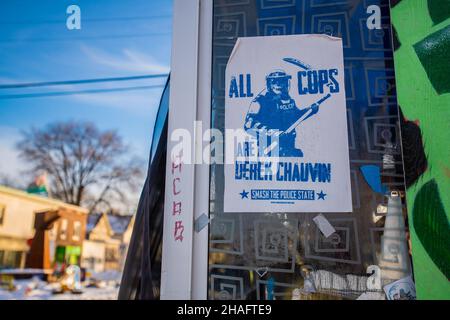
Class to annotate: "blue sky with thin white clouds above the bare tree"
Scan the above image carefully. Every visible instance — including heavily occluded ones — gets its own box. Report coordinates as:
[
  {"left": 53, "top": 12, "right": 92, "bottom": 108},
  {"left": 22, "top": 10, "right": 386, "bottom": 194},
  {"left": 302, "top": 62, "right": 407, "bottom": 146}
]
[{"left": 0, "top": 0, "right": 172, "bottom": 185}]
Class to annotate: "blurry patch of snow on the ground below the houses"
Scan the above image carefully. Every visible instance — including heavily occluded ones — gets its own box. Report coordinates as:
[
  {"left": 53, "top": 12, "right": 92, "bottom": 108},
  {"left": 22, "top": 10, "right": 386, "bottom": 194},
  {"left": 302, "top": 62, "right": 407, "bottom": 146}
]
[{"left": 0, "top": 273, "right": 120, "bottom": 300}]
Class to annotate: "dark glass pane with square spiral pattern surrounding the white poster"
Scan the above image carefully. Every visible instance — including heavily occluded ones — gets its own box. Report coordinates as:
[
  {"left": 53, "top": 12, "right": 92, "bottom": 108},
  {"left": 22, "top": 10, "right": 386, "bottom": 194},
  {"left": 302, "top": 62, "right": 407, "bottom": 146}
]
[{"left": 208, "top": 0, "right": 411, "bottom": 300}]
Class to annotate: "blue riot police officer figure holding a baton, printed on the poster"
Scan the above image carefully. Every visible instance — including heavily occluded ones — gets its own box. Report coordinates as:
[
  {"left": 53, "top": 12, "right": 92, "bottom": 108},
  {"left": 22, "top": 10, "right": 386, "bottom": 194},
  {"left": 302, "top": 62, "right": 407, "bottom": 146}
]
[{"left": 244, "top": 70, "right": 329, "bottom": 157}]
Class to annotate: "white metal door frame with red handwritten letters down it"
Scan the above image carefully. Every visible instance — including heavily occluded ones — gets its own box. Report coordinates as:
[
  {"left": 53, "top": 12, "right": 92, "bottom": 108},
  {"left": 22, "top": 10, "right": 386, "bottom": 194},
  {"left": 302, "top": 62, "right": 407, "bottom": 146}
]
[{"left": 161, "top": 0, "right": 213, "bottom": 300}]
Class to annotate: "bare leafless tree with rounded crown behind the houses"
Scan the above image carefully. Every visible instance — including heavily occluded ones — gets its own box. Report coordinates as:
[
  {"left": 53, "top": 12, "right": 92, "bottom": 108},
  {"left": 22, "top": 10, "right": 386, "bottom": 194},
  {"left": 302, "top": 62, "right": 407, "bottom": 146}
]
[{"left": 17, "top": 122, "right": 143, "bottom": 210}]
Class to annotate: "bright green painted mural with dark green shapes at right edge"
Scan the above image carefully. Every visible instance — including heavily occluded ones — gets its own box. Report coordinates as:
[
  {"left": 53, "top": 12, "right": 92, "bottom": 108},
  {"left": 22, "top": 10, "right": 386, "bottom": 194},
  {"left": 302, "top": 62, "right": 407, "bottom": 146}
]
[{"left": 391, "top": 0, "right": 450, "bottom": 299}]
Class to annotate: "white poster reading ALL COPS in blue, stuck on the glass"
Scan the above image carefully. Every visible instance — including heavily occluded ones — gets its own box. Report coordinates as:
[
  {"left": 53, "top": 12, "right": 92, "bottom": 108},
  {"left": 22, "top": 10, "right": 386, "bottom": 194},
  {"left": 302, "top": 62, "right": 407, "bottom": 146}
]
[{"left": 224, "top": 35, "right": 352, "bottom": 212}]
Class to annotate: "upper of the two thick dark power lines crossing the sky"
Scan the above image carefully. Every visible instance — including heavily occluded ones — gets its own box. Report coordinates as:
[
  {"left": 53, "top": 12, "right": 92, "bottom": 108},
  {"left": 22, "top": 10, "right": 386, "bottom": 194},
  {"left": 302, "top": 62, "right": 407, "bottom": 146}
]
[{"left": 0, "top": 73, "right": 169, "bottom": 89}]
